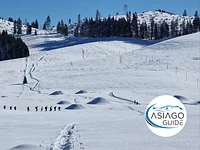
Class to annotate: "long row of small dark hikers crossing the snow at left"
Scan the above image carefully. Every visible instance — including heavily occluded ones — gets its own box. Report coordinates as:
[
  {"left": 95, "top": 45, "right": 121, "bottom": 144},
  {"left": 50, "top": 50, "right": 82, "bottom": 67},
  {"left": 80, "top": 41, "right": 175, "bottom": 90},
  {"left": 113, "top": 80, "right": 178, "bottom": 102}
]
[{"left": 3, "top": 105, "right": 61, "bottom": 112}]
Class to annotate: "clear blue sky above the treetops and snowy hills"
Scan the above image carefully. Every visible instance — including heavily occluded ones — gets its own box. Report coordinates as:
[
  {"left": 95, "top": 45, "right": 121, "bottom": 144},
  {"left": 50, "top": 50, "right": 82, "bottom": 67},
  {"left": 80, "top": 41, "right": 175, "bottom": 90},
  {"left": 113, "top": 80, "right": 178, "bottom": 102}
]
[{"left": 0, "top": 0, "right": 200, "bottom": 26}]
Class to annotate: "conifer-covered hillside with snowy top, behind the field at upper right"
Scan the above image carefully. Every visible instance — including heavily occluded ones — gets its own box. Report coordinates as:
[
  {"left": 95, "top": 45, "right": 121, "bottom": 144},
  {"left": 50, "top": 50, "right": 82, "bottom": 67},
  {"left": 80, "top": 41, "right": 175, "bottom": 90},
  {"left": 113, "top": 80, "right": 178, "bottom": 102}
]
[{"left": 74, "top": 10, "right": 200, "bottom": 40}]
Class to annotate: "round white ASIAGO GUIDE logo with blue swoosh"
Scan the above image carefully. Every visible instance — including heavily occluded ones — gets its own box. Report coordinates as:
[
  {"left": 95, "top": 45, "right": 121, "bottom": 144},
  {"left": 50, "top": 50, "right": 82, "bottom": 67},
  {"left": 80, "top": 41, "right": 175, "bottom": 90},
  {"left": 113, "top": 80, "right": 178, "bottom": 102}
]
[{"left": 145, "top": 95, "right": 187, "bottom": 137}]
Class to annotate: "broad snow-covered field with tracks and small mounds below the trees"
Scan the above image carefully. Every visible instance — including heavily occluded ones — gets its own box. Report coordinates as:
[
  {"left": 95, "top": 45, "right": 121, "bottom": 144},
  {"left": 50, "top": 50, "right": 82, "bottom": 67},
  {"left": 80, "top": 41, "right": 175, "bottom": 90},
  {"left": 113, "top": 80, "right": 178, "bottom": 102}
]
[{"left": 0, "top": 32, "right": 200, "bottom": 150}]
